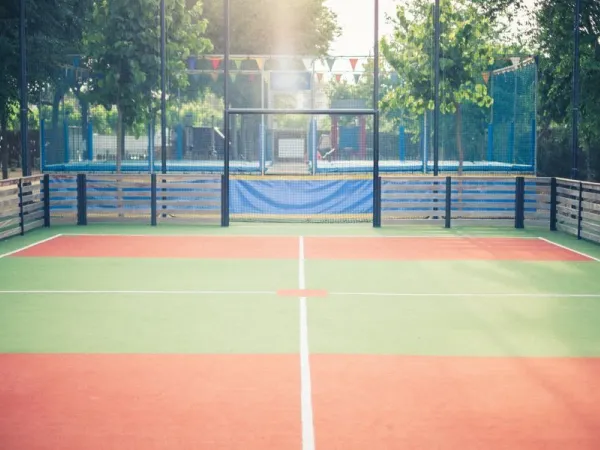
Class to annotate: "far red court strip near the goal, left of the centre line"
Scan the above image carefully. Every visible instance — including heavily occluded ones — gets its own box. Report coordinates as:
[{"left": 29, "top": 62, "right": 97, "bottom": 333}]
[{"left": 14, "top": 236, "right": 299, "bottom": 259}]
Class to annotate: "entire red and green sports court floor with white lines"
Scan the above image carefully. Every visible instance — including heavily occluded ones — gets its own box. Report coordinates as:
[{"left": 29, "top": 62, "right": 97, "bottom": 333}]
[{"left": 0, "top": 224, "right": 600, "bottom": 450}]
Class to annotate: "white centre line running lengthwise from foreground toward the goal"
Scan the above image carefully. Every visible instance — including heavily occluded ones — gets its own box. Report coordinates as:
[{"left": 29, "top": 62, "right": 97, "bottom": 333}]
[{"left": 298, "top": 236, "right": 315, "bottom": 450}]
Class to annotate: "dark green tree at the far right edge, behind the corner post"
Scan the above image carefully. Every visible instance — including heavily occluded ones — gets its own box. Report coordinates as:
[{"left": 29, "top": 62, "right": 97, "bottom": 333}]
[{"left": 536, "top": 0, "right": 600, "bottom": 179}]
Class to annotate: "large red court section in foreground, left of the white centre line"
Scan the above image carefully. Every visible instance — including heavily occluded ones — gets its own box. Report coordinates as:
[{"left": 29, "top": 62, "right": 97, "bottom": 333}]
[{"left": 0, "top": 354, "right": 301, "bottom": 450}]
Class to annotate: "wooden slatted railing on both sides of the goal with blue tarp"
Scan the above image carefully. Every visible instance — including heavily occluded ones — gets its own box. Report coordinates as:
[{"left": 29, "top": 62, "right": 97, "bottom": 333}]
[{"left": 0, "top": 174, "right": 600, "bottom": 243}]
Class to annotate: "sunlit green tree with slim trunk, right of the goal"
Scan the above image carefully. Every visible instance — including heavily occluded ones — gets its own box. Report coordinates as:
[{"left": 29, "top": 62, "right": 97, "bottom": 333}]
[{"left": 382, "top": 0, "right": 494, "bottom": 174}]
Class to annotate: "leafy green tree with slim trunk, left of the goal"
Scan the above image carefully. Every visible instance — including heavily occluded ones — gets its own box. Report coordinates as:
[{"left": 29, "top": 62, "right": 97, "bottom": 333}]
[{"left": 85, "top": 0, "right": 211, "bottom": 169}]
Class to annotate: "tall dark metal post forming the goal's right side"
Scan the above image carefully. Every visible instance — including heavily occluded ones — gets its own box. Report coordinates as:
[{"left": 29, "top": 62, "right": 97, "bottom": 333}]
[{"left": 373, "top": 0, "right": 381, "bottom": 228}]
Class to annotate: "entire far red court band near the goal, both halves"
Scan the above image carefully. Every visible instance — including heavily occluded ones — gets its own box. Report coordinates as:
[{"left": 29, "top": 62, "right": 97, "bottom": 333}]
[{"left": 14, "top": 236, "right": 593, "bottom": 261}]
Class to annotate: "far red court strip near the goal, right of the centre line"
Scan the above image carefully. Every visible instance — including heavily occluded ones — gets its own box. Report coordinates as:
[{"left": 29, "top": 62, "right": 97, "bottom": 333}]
[{"left": 305, "top": 237, "right": 593, "bottom": 261}]
